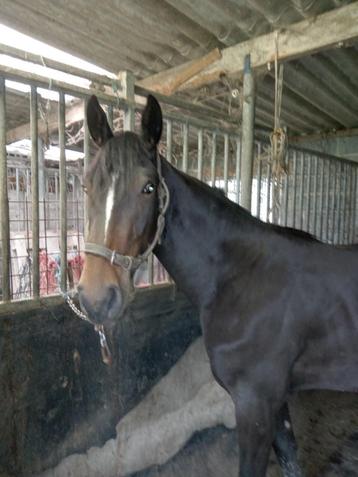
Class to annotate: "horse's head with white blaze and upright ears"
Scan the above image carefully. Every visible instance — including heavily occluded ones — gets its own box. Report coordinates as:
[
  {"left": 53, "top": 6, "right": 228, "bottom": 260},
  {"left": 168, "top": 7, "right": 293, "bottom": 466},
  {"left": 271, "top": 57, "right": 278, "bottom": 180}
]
[{"left": 78, "top": 96, "right": 163, "bottom": 323}]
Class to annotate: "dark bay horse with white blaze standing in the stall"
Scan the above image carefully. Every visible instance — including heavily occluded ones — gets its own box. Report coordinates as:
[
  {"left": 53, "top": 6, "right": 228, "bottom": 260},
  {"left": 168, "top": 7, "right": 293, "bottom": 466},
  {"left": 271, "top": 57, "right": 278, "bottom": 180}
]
[{"left": 79, "top": 96, "right": 358, "bottom": 477}]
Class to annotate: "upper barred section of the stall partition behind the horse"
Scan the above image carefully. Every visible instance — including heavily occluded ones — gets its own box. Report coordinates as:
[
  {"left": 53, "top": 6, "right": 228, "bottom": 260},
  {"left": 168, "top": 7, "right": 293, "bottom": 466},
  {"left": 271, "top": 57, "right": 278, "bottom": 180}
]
[{"left": 0, "top": 65, "right": 357, "bottom": 301}]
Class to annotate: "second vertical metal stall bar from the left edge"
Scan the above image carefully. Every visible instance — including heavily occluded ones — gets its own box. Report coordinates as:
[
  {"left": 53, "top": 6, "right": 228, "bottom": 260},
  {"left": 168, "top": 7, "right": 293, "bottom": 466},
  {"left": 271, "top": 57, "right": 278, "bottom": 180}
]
[{"left": 30, "top": 86, "right": 40, "bottom": 298}]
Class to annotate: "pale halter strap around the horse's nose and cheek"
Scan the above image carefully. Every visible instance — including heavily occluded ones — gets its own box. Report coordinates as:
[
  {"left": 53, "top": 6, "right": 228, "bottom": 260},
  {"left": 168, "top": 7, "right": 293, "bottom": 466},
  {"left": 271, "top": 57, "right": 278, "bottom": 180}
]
[{"left": 84, "top": 152, "right": 170, "bottom": 272}]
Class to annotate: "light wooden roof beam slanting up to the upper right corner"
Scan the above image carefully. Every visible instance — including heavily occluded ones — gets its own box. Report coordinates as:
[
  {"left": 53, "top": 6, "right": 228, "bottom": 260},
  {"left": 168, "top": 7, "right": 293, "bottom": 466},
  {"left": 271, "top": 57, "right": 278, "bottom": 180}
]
[{"left": 142, "top": 2, "right": 358, "bottom": 94}]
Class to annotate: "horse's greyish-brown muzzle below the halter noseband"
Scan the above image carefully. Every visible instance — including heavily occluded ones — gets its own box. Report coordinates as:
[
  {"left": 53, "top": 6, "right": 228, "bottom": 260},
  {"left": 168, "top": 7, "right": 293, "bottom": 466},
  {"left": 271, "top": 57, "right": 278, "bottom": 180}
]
[{"left": 78, "top": 285, "right": 123, "bottom": 324}]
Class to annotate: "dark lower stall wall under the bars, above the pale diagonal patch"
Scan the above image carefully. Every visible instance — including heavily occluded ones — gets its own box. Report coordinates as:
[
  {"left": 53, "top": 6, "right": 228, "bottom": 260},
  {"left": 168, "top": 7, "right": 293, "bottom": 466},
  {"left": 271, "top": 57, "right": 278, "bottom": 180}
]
[{"left": 0, "top": 289, "right": 200, "bottom": 477}]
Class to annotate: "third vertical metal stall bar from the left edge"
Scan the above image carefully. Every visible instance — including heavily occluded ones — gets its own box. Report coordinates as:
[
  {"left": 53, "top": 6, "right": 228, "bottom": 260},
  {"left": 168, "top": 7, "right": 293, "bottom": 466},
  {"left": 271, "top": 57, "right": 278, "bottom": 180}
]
[{"left": 58, "top": 91, "right": 67, "bottom": 292}]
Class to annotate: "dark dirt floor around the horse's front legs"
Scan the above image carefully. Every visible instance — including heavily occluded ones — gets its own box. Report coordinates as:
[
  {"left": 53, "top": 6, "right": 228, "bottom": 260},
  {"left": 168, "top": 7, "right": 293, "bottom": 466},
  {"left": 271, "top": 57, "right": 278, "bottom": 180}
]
[{"left": 132, "top": 392, "right": 358, "bottom": 477}]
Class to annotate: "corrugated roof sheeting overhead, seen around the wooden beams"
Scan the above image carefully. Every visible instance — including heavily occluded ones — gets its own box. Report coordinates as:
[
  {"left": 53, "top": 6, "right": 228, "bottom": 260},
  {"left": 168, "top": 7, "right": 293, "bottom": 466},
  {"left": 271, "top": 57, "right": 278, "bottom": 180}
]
[{"left": 0, "top": 0, "right": 358, "bottom": 138}]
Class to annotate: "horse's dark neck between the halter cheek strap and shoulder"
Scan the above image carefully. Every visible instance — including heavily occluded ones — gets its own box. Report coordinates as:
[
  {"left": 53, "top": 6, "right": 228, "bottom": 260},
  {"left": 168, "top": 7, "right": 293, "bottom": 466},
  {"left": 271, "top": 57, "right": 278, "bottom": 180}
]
[{"left": 155, "top": 161, "right": 258, "bottom": 307}]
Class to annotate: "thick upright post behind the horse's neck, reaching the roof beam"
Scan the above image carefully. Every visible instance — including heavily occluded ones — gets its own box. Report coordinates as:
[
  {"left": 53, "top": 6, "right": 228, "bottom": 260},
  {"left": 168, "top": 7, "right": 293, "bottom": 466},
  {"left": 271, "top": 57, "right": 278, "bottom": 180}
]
[{"left": 241, "top": 55, "right": 255, "bottom": 211}]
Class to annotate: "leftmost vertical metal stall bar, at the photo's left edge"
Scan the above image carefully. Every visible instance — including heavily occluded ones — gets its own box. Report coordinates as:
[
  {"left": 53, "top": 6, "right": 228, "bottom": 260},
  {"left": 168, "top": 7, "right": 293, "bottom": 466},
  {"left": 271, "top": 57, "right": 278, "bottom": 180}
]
[{"left": 0, "top": 78, "right": 11, "bottom": 301}]
